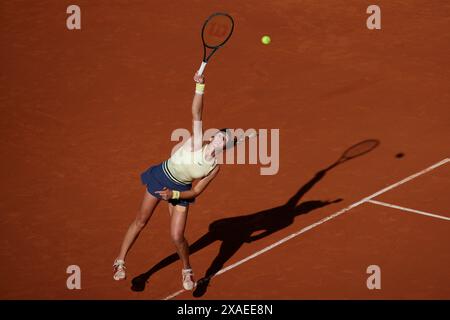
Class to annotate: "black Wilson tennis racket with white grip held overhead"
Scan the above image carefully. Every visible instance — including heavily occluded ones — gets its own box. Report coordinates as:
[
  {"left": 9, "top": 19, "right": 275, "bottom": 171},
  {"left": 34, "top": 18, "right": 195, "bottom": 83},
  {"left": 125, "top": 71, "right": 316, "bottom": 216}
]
[{"left": 198, "top": 12, "right": 234, "bottom": 76}]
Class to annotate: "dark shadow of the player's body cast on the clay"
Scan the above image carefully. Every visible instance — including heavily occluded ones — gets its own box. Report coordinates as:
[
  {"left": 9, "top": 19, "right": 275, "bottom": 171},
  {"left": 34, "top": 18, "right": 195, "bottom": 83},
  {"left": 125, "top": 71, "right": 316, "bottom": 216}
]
[{"left": 131, "top": 140, "right": 378, "bottom": 297}]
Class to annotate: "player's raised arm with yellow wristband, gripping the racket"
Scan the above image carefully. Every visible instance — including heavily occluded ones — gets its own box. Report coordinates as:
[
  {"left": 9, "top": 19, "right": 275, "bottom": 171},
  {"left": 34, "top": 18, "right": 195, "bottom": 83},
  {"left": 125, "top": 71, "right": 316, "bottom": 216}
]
[{"left": 191, "top": 73, "right": 205, "bottom": 151}]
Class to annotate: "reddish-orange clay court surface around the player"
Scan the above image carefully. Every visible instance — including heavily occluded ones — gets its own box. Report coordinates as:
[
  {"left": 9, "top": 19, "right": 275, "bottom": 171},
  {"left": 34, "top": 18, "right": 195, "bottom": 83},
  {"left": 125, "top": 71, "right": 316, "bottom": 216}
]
[{"left": 0, "top": 0, "right": 450, "bottom": 299}]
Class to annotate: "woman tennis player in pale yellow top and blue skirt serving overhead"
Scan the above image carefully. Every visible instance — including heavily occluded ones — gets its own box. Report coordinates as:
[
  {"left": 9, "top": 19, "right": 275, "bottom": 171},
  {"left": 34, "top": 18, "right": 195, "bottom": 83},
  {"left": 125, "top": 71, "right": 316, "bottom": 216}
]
[{"left": 113, "top": 73, "right": 236, "bottom": 290}]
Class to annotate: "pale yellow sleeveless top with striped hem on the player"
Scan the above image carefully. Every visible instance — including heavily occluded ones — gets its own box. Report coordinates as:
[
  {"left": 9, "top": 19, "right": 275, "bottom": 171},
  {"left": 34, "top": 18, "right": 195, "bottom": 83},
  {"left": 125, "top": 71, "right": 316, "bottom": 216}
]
[{"left": 163, "top": 144, "right": 217, "bottom": 184}]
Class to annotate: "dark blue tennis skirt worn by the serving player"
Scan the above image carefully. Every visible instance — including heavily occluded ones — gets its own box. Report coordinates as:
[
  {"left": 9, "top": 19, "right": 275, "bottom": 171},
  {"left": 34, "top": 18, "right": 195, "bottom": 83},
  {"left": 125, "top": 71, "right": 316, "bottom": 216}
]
[{"left": 141, "top": 162, "right": 195, "bottom": 207}]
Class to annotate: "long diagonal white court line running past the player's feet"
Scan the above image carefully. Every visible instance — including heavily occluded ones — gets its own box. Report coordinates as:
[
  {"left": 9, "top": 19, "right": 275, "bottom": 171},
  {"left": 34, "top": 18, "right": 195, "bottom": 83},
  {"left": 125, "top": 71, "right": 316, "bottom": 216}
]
[{"left": 163, "top": 158, "right": 450, "bottom": 300}]
